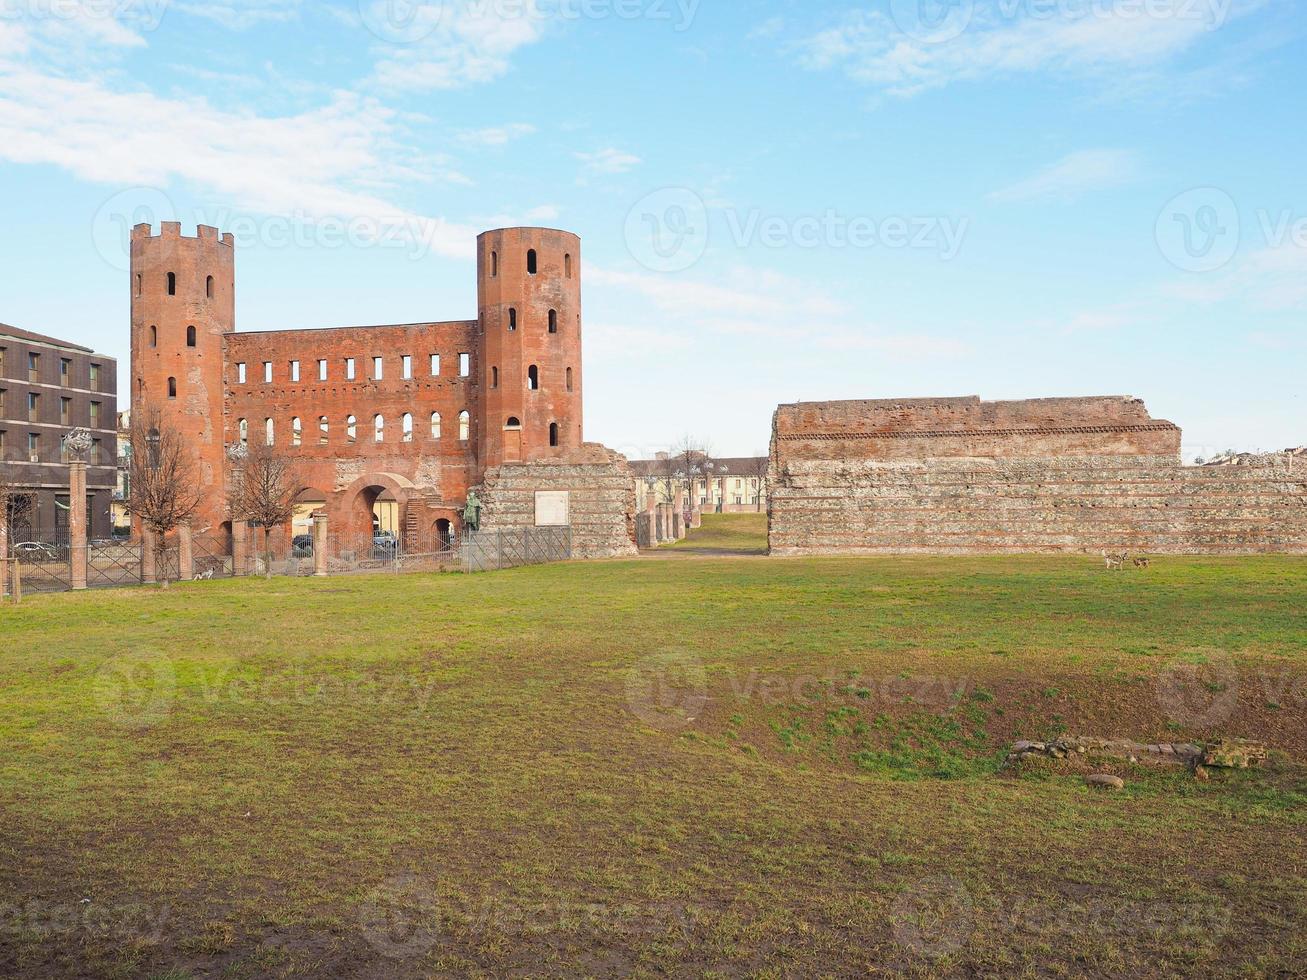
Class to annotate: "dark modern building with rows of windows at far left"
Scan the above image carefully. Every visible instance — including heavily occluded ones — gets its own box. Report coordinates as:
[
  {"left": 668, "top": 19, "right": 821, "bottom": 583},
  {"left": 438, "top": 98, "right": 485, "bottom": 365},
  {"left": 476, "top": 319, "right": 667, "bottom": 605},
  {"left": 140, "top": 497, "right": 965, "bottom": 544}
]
[{"left": 0, "top": 323, "right": 118, "bottom": 544}]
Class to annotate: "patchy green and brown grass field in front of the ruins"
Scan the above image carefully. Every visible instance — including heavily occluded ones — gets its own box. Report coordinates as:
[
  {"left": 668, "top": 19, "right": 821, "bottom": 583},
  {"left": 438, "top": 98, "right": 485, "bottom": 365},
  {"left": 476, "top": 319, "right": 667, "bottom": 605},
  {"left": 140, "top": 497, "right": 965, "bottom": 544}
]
[{"left": 0, "top": 521, "right": 1307, "bottom": 980}]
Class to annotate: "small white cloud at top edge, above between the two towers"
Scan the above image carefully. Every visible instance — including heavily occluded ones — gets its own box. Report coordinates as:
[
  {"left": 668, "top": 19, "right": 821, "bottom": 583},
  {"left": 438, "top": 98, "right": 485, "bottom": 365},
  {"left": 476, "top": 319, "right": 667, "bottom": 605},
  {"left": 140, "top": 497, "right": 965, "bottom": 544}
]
[{"left": 361, "top": 0, "right": 545, "bottom": 91}]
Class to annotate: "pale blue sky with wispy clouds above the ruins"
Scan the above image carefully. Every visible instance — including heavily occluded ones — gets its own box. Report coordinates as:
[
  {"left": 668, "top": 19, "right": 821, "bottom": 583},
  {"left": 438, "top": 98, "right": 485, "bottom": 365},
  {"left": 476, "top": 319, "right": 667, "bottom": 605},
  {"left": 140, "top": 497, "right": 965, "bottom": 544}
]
[{"left": 0, "top": 0, "right": 1307, "bottom": 456}]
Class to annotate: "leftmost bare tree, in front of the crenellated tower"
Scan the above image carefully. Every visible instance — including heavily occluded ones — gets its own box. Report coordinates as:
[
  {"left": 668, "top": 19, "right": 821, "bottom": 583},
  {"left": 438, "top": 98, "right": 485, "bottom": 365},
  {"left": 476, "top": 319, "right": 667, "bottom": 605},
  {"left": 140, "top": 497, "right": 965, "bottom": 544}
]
[{"left": 128, "top": 405, "right": 203, "bottom": 588}]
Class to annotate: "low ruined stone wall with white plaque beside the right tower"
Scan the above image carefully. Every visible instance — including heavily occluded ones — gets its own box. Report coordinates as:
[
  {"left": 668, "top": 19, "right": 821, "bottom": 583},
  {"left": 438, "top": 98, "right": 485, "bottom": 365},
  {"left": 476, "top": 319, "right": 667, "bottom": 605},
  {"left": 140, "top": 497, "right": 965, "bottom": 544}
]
[{"left": 480, "top": 443, "right": 637, "bottom": 558}]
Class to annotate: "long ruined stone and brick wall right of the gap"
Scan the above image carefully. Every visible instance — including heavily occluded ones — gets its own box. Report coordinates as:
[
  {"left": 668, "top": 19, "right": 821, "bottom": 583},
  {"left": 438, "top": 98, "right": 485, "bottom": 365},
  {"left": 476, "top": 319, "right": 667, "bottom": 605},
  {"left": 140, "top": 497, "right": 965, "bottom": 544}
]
[{"left": 770, "top": 400, "right": 1307, "bottom": 554}]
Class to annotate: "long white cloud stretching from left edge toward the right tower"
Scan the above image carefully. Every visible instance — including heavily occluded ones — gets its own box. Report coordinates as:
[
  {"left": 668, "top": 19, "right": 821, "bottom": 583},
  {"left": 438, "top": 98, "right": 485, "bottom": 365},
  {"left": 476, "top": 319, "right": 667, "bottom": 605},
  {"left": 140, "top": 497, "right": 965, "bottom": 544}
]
[{"left": 0, "top": 72, "right": 476, "bottom": 257}]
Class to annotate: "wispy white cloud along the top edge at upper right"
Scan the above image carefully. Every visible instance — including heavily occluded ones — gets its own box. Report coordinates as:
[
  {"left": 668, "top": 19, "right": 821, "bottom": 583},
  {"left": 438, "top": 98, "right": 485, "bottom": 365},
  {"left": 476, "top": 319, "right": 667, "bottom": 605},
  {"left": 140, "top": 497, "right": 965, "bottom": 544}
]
[{"left": 793, "top": 0, "right": 1266, "bottom": 97}]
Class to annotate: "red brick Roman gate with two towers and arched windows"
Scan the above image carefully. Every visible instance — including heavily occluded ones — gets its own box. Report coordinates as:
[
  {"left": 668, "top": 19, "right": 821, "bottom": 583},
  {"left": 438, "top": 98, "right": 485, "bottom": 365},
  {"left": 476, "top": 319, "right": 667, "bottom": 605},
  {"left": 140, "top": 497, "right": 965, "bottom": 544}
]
[{"left": 131, "top": 222, "right": 622, "bottom": 559}]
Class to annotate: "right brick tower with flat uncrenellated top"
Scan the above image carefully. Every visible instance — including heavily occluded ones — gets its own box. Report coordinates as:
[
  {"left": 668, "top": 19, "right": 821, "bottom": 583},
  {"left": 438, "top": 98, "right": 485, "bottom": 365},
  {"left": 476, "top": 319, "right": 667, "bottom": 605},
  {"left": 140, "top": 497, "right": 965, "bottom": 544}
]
[{"left": 474, "top": 227, "right": 583, "bottom": 469}]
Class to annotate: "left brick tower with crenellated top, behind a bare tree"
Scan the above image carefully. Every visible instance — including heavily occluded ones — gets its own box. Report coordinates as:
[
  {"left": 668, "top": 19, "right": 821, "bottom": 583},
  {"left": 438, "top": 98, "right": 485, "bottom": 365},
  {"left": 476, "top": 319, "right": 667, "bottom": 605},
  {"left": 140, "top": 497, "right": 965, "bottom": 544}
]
[{"left": 131, "top": 221, "right": 235, "bottom": 531}]
